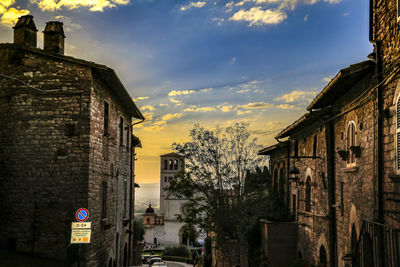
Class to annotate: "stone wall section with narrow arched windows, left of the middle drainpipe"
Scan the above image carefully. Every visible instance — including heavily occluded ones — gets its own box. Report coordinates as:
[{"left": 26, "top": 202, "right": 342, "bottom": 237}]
[{"left": 290, "top": 120, "right": 329, "bottom": 263}]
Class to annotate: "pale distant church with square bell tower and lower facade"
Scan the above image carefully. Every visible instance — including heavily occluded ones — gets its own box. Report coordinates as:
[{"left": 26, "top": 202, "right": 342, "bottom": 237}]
[{"left": 143, "top": 153, "right": 191, "bottom": 246}]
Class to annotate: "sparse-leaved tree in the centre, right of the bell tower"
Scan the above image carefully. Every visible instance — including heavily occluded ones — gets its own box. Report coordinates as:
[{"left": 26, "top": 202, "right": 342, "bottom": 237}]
[{"left": 167, "top": 122, "right": 271, "bottom": 262}]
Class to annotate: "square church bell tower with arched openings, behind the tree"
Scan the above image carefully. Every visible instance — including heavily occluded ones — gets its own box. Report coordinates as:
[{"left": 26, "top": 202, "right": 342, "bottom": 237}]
[{"left": 160, "top": 153, "right": 185, "bottom": 221}]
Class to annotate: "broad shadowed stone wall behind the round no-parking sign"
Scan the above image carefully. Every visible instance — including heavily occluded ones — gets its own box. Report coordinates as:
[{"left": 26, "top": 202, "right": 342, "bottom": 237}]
[{"left": 0, "top": 45, "right": 91, "bottom": 260}]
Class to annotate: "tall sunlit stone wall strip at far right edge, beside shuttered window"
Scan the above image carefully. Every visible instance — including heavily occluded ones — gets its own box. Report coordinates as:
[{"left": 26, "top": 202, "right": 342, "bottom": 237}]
[{"left": 373, "top": 0, "right": 400, "bottom": 228}]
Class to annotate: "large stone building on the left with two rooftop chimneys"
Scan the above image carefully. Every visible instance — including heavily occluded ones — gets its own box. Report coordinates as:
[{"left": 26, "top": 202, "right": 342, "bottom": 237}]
[{"left": 0, "top": 15, "right": 144, "bottom": 266}]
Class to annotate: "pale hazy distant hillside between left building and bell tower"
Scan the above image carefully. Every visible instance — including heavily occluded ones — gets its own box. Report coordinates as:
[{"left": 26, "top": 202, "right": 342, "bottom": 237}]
[{"left": 135, "top": 183, "right": 160, "bottom": 213}]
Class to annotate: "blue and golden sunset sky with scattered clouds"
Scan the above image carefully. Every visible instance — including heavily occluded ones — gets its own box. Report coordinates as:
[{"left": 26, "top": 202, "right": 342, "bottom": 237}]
[{"left": 0, "top": 0, "right": 372, "bottom": 183}]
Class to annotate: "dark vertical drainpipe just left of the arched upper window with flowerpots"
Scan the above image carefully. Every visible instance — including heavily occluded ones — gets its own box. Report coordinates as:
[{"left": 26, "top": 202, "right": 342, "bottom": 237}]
[{"left": 325, "top": 120, "right": 338, "bottom": 267}]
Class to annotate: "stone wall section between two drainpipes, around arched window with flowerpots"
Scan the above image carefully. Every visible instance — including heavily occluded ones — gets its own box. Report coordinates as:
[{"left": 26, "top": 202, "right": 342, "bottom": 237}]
[{"left": 334, "top": 76, "right": 377, "bottom": 266}]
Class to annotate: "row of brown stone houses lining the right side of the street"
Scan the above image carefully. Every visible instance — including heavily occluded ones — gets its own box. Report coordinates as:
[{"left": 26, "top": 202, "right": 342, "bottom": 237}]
[{"left": 260, "top": 0, "right": 400, "bottom": 266}]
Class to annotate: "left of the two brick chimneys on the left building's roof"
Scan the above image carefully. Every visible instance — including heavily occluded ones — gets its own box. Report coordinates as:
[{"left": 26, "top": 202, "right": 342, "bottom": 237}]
[{"left": 13, "top": 15, "right": 37, "bottom": 47}]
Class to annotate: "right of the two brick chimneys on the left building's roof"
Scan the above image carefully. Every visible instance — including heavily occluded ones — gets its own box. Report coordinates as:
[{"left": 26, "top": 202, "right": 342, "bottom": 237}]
[{"left": 43, "top": 21, "right": 65, "bottom": 55}]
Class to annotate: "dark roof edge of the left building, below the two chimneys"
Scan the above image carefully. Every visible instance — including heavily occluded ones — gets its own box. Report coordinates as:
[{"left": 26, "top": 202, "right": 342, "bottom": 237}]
[{"left": 0, "top": 43, "right": 144, "bottom": 120}]
